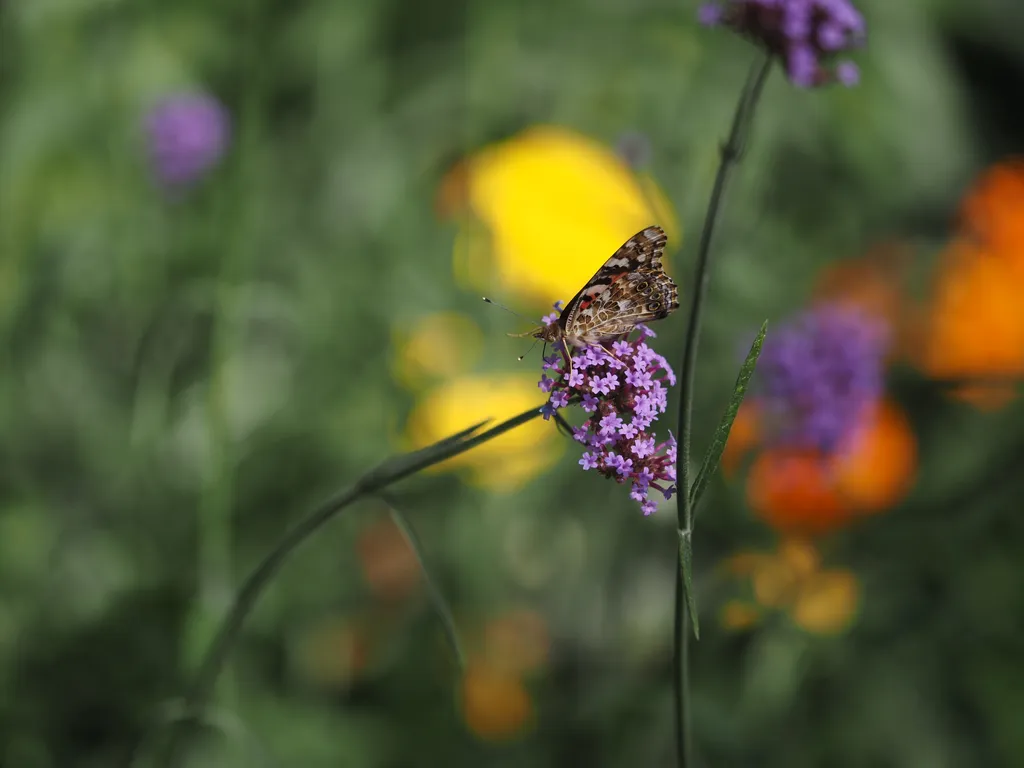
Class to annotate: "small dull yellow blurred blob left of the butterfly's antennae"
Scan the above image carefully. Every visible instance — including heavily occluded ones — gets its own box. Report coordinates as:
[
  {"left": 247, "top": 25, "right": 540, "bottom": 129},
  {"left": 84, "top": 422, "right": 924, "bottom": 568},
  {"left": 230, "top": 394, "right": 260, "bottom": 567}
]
[{"left": 392, "top": 312, "right": 482, "bottom": 388}]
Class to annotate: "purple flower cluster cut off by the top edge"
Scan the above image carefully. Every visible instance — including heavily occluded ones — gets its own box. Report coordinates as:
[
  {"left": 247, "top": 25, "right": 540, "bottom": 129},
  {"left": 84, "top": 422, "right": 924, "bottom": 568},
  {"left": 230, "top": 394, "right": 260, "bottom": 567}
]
[{"left": 698, "top": 0, "right": 865, "bottom": 88}]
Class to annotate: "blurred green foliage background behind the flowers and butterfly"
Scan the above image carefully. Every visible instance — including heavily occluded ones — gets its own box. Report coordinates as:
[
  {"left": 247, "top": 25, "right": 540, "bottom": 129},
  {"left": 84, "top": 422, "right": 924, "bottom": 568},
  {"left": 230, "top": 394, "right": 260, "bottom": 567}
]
[{"left": 0, "top": 0, "right": 1024, "bottom": 768}]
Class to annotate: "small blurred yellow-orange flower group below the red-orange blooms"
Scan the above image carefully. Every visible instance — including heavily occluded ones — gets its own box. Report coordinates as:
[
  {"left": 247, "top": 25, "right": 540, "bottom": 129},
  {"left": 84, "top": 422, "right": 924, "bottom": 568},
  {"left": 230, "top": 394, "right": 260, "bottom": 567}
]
[{"left": 721, "top": 539, "right": 860, "bottom": 635}]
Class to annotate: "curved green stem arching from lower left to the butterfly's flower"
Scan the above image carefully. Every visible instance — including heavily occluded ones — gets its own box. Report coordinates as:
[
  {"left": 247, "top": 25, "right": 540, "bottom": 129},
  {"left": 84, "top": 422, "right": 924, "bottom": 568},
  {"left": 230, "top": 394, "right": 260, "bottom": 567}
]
[{"left": 145, "top": 407, "right": 541, "bottom": 766}]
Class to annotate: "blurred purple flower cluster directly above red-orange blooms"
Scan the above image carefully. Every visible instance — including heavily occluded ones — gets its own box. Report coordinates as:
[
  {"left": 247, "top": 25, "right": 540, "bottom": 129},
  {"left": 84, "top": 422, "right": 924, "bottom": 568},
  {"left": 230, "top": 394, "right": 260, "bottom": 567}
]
[{"left": 757, "top": 306, "right": 887, "bottom": 453}]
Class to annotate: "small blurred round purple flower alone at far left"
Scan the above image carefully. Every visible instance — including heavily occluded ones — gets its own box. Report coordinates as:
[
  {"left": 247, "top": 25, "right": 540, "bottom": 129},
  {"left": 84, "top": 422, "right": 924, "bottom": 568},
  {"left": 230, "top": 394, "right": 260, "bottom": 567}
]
[{"left": 145, "top": 93, "right": 230, "bottom": 188}]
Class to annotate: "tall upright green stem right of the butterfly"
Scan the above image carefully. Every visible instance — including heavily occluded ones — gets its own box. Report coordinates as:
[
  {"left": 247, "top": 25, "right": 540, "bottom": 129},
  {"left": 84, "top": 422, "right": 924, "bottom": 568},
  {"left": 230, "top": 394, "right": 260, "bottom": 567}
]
[{"left": 673, "top": 55, "right": 771, "bottom": 768}]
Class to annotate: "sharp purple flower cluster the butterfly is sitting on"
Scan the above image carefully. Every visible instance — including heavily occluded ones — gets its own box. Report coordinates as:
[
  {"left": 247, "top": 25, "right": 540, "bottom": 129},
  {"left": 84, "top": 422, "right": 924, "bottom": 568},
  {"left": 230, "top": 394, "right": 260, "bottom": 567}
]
[{"left": 539, "top": 314, "right": 676, "bottom": 515}]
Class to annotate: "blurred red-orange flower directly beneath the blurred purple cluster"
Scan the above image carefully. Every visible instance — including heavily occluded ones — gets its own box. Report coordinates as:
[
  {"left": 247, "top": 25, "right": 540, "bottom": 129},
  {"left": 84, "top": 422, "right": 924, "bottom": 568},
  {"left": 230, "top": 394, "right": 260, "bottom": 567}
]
[{"left": 730, "top": 401, "right": 918, "bottom": 536}]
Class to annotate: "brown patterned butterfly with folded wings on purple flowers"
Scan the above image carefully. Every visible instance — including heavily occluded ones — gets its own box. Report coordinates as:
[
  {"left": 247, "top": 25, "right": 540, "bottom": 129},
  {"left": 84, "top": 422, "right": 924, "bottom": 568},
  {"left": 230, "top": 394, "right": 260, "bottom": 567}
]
[{"left": 522, "top": 226, "right": 679, "bottom": 354}]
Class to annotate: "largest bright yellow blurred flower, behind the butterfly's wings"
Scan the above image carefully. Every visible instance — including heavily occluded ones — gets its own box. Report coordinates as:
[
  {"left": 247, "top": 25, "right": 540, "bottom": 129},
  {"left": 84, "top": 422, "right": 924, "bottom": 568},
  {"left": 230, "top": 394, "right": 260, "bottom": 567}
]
[{"left": 438, "top": 126, "right": 679, "bottom": 305}]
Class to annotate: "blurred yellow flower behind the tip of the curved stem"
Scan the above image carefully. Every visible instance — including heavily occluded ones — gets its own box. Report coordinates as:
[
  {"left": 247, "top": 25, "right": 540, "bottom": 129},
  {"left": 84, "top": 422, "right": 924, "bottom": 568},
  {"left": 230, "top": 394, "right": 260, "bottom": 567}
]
[{"left": 408, "top": 375, "right": 565, "bottom": 490}]
